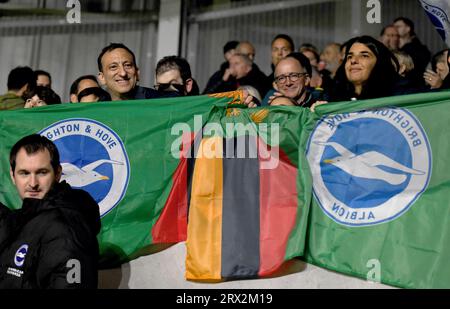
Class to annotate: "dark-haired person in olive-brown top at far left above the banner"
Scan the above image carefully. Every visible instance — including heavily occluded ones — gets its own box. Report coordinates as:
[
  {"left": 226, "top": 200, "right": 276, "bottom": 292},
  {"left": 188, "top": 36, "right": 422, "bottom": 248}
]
[{"left": 0, "top": 67, "right": 36, "bottom": 111}]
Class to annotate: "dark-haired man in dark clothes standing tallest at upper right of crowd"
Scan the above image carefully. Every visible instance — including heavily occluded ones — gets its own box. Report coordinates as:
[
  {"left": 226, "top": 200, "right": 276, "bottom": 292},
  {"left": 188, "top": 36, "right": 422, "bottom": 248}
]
[{"left": 394, "top": 17, "right": 431, "bottom": 82}]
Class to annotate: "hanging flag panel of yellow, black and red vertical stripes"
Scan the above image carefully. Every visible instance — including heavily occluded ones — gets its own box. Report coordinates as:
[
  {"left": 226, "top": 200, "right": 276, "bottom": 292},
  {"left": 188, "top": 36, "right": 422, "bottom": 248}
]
[{"left": 186, "top": 135, "right": 298, "bottom": 280}]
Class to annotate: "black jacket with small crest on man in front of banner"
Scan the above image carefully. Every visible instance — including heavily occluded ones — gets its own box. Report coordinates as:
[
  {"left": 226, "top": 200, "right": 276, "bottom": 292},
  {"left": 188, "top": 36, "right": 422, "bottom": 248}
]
[{"left": 0, "top": 181, "right": 100, "bottom": 289}]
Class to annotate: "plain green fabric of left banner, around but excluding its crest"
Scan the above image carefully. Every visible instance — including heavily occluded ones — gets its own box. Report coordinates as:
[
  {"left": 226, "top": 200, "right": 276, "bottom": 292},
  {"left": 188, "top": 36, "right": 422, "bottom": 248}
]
[{"left": 0, "top": 96, "right": 231, "bottom": 267}]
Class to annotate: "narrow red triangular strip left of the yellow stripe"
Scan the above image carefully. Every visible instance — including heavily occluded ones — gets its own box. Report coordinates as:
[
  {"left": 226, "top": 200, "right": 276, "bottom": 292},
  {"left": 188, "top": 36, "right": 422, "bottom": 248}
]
[{"left": 152, "top": 133, "right": 194, "bottom": 243}]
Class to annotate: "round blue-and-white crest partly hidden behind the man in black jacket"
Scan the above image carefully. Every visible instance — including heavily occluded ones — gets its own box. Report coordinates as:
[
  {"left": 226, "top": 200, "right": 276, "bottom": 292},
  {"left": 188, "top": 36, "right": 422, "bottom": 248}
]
[{"left": 39, "top": 119, "right": 130, "bottom": 216}]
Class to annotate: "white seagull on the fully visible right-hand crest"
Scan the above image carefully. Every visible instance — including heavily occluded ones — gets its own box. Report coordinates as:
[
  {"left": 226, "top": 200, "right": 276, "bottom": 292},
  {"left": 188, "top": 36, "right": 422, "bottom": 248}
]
[{"left": 316, "top": 142, "right": 425, "bottom": 185}]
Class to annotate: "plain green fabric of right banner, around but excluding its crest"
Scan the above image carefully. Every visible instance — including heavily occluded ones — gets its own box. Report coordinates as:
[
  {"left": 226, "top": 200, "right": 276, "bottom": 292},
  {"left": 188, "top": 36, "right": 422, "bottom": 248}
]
[{"left": 305, "top": 92, "right": 450, "bottom": 288}]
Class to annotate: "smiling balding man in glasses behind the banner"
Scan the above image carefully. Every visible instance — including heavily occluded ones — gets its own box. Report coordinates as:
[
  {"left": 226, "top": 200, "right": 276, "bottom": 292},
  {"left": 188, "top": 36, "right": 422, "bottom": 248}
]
[{"left": 269, "top": 53, "right": 326, "bottom": 108}]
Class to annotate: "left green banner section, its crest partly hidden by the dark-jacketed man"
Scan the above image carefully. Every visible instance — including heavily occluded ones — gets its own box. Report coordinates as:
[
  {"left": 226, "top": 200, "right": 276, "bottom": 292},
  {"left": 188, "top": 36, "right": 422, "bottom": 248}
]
[{"left": 0, "top": 92, "right": 234, "bottom": 267}]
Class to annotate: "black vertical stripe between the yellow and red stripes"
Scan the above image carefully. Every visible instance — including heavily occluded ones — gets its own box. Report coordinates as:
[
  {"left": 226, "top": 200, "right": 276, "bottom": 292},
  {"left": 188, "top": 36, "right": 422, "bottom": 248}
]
[{"left": 221, "top": 136, "right": 260, "bottom": 279}]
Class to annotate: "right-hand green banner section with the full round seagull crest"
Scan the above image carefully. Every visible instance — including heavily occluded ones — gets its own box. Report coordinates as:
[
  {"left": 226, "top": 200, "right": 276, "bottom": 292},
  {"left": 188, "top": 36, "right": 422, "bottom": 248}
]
[{"left": 305, "top": 92, "right": 450, "bottom": 288}]
